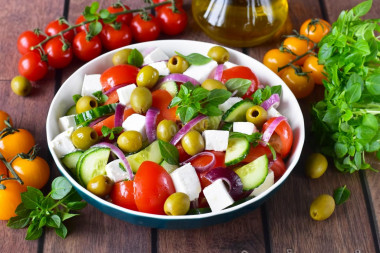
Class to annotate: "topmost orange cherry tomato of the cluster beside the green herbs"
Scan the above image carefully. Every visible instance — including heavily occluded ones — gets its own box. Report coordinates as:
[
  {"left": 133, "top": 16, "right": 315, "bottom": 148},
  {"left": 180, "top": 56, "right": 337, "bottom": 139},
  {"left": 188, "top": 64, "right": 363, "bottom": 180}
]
[{"left": 300, "top": 18, "right": 331, "bottom": 43}]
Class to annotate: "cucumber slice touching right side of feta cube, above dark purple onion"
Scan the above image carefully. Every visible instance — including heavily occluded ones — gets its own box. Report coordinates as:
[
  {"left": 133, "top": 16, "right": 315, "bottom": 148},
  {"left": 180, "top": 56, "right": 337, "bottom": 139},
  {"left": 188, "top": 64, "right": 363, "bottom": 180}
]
[{"left": 224, "top": 138, "right": 250, "bottom": 166}]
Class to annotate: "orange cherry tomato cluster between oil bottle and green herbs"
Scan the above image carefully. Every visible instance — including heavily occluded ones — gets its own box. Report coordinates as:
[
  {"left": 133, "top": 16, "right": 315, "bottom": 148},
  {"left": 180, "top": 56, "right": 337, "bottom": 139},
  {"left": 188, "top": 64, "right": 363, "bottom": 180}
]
[{"left": 263, "top": 19, "right": 331, "bottom": 98}]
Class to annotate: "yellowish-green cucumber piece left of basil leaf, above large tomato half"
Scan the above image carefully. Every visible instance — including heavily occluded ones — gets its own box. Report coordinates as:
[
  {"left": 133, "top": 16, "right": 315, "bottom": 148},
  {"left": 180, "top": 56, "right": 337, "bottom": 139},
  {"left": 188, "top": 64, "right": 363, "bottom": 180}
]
[{"left": 127, "top": 141, "right": 163, "bottom": 173}]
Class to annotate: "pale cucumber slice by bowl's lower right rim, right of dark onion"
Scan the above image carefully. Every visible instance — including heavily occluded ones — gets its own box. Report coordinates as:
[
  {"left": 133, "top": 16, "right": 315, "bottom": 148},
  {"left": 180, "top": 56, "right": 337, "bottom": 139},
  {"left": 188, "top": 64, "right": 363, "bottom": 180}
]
[{"left": 235, "top": 155, "right": 268, "bottom": 191}]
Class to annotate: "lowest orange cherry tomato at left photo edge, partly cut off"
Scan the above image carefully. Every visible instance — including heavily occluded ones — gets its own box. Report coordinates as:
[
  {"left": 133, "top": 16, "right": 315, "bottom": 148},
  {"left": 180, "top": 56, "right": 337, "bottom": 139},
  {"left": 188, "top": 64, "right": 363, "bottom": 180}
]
[{"left": 0, "top": 180, "right": 26, "bottom": 220}]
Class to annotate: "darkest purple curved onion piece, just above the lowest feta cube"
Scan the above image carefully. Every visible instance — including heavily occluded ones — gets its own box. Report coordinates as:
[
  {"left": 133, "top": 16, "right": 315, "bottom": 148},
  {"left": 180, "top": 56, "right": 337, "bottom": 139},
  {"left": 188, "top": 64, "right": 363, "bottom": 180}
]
[{"left": 205, "top": 167, "right": 243, "bottom": 200}]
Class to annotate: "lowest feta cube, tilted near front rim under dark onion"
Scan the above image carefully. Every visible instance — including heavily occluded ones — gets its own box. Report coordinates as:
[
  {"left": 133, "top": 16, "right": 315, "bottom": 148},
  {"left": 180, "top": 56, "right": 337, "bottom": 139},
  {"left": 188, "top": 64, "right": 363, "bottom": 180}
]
[{"left": 203, "top": 179, "right": 234, "bottom": 212}]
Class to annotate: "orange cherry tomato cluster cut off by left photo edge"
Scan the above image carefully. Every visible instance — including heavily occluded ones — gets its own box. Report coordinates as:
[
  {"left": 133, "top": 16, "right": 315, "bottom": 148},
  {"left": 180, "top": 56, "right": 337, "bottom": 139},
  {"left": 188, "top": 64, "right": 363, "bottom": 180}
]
[{"left": 0, "top": 111, "right": 50, "bottom": 220}]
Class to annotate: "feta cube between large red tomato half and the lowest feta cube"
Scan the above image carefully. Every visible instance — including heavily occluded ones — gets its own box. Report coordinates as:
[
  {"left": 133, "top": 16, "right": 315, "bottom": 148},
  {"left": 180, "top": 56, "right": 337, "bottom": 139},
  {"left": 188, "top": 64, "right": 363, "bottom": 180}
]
[{"left": 170, "top": 163, "right": 202, "bottom": 201}]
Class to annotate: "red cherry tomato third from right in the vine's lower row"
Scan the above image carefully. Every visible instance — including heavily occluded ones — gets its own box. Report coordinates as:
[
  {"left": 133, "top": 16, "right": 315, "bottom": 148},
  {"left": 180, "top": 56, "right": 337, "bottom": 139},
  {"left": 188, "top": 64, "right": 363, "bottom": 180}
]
[{"left": 100, "top": 23, "right": 132, "bottom": 50}]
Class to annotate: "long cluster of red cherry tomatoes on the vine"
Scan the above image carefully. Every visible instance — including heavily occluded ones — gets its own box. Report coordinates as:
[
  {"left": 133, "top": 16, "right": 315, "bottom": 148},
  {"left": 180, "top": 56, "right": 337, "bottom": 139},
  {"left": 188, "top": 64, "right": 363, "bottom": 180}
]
[{"left": 12, "top": 0, "right": 187, "bottom": 90}]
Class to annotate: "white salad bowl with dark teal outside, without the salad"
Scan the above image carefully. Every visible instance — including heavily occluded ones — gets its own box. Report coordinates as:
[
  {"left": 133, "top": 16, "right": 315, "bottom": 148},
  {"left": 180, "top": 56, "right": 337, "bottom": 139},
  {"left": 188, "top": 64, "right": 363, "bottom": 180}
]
[{"left": 46, "top": 40, "right": 305, "bottom": 229}]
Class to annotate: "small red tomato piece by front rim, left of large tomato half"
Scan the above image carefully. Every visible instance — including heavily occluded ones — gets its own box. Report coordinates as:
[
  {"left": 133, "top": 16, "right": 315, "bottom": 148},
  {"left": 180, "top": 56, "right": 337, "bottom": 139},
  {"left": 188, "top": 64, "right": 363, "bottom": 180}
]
[{"left": 110, "top": 181, "right": 137, "bottom": 211}]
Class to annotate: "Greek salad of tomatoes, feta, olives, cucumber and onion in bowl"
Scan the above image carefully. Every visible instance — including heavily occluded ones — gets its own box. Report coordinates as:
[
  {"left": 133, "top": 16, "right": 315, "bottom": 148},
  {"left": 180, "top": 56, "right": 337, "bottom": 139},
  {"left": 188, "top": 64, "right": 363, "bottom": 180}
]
[{"left": 49, "top": 46, "right": 293, "bottom": 215}]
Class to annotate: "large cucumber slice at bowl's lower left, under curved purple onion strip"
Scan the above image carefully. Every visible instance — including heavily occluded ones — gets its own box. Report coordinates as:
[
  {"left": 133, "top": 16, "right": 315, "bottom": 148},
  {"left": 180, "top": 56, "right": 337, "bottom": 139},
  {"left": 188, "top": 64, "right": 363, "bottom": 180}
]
[{"left": 77, "top": 148, "right": 111, "bottom": 186}]
